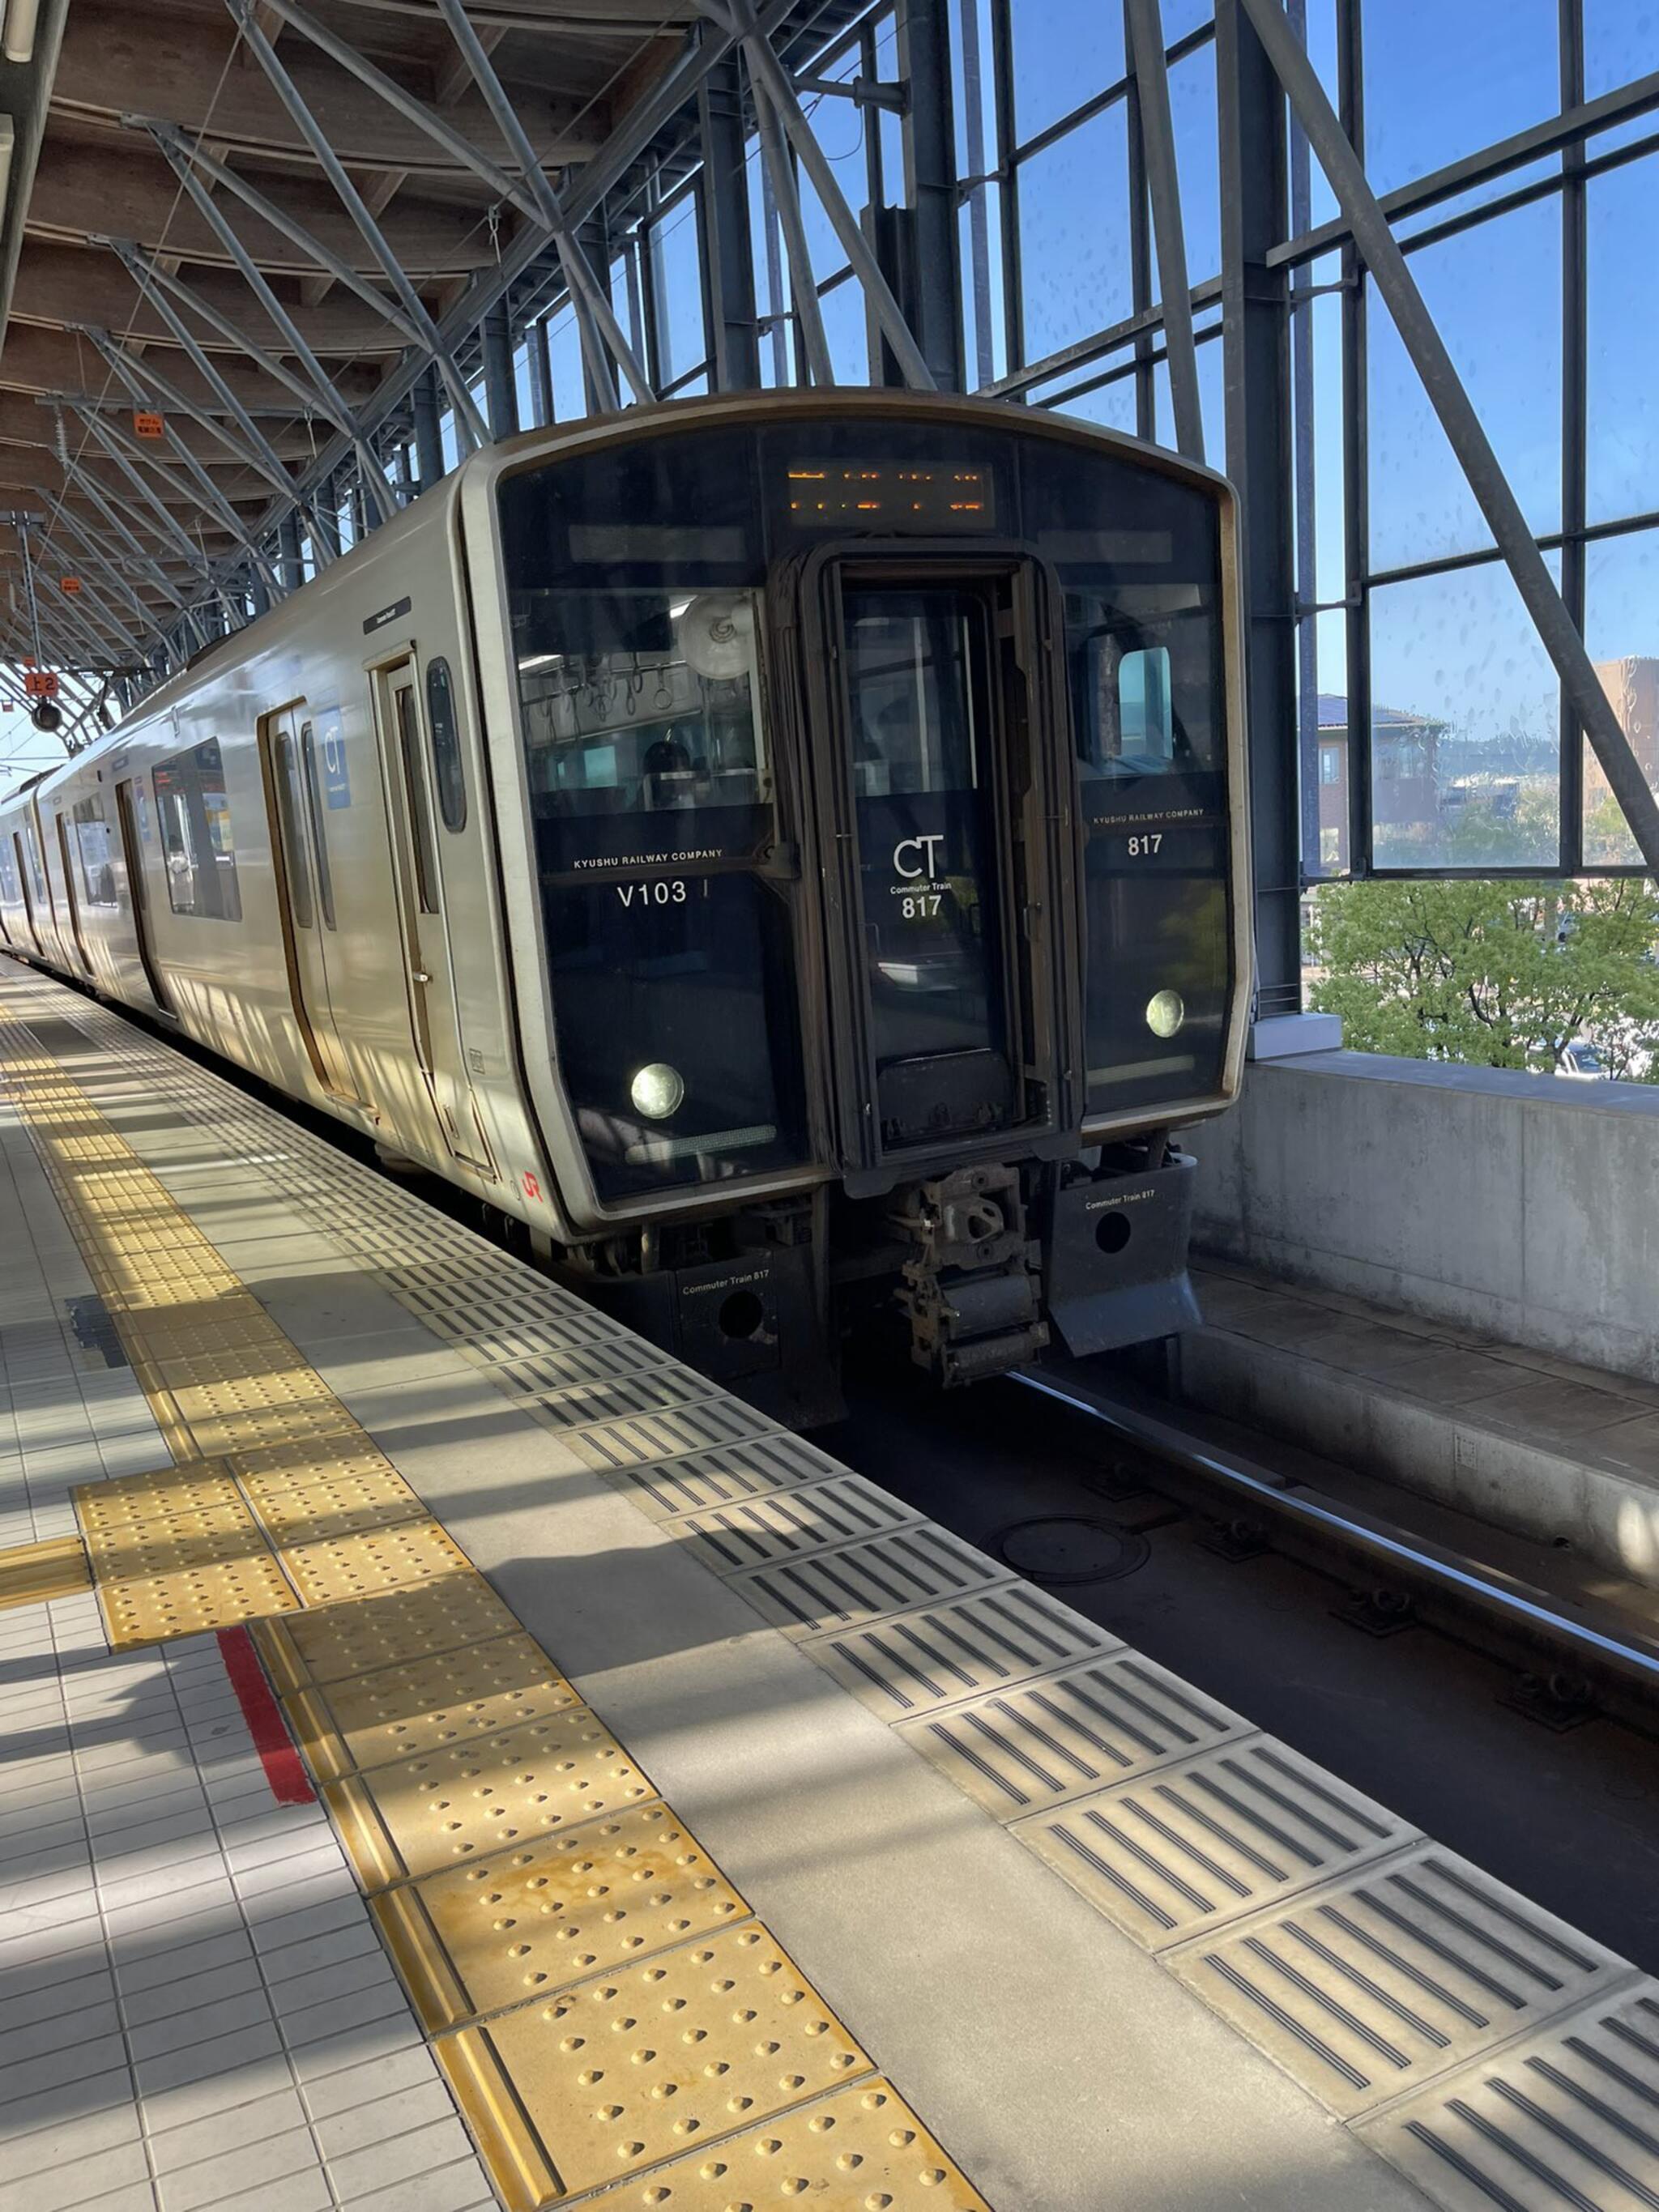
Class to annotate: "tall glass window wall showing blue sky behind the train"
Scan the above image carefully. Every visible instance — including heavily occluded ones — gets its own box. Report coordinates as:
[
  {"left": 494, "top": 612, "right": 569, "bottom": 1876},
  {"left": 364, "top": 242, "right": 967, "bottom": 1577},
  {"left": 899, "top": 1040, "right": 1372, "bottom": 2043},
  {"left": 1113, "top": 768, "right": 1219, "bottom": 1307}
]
[{"left": 382, "top": 0, "right": 1659, "bottom": 897}]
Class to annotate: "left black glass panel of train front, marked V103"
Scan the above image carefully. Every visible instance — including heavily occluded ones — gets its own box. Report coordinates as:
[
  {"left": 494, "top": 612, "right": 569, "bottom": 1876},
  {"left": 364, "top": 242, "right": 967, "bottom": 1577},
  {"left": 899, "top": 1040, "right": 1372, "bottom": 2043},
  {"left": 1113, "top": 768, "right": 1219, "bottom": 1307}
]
[{"left": 514, "top": 442, "right": 808, "bottom": 1196}]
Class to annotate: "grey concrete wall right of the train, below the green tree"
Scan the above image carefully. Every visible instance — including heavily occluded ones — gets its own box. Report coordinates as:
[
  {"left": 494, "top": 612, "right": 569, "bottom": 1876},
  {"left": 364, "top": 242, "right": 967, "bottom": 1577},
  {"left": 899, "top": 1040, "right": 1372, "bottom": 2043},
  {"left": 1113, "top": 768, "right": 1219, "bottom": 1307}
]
[{"left": 1186, "top": 1053, "right": 1659, "bottom": 1383}]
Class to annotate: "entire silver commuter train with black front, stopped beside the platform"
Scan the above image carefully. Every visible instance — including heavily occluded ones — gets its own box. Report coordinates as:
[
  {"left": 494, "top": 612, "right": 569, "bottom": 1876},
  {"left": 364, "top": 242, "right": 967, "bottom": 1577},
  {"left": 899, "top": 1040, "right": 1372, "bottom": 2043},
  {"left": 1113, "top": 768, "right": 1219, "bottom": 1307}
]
[{"left": 0, "top": 391, "right": 1250, "bottom": 1420}]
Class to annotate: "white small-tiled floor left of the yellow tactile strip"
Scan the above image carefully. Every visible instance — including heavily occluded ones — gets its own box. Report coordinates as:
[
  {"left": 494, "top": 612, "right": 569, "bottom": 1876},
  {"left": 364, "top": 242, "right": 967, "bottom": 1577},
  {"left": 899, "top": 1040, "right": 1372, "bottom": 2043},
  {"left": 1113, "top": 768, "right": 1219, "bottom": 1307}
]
[{"left": 0, "top": 1115, "right": 496, "bottom": 2212}]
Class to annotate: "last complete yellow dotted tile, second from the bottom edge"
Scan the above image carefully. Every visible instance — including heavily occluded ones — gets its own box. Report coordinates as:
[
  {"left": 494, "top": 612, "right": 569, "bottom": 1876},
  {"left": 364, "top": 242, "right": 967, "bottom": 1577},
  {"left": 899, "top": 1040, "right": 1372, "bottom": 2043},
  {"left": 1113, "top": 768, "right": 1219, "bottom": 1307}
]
[{"left": 433, "top": 1927, "right": 872, "bottom": 2192}]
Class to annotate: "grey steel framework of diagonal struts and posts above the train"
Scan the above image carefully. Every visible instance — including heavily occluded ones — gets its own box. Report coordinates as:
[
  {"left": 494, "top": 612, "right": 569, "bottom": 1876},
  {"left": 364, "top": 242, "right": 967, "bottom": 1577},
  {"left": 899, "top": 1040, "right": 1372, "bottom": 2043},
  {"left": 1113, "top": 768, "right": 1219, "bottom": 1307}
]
[{"left": 10, "top": 0, "right": 1659, "bottom": 915}]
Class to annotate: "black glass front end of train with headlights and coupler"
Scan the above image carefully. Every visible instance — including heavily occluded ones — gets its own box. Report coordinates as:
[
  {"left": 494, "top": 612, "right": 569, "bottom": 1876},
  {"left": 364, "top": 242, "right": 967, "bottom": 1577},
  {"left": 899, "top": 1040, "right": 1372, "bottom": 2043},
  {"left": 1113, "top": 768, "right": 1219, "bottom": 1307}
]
[{"left": 477, "top": 394, "right": 1243, "bottom": 1380}]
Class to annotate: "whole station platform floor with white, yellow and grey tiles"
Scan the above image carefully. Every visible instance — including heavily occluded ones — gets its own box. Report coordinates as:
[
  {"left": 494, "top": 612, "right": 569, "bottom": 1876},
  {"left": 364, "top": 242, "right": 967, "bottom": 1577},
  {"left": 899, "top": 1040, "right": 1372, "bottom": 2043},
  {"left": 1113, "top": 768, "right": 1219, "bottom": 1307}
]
[{"left": 0, "top": 962, "right": 1659, "bottom": 2212}]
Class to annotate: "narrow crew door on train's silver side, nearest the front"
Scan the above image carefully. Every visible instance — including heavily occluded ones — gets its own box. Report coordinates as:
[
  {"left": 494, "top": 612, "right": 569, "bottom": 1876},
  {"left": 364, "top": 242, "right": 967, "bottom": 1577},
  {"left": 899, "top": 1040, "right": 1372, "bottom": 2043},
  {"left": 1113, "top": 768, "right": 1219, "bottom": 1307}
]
[{"left": 373, "top": 653, "right": 496, "bottom": 1179}]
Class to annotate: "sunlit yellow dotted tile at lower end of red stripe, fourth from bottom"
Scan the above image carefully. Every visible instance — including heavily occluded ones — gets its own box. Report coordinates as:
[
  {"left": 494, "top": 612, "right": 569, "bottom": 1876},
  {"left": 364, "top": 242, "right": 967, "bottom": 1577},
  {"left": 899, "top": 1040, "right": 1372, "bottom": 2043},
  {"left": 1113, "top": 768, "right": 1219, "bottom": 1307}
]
[{"left": 325, "top": 1706, "right": 657, "bottom": 1885}]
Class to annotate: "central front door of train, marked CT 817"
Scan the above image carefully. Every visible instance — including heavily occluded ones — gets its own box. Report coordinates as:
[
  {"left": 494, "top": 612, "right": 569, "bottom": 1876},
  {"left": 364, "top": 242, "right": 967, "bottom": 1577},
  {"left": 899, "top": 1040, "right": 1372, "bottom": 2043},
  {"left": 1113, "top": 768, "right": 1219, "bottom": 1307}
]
[{"left": 814, "top": 560, "right": 1066, "bottom": 1170}]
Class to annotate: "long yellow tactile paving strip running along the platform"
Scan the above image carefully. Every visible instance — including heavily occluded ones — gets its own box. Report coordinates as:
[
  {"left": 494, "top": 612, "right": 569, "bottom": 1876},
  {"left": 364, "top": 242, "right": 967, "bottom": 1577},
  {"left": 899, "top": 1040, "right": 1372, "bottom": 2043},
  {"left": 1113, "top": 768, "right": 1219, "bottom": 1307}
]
[{"left": 0, "top": 1020, "right": 982, "bottom": 2212}]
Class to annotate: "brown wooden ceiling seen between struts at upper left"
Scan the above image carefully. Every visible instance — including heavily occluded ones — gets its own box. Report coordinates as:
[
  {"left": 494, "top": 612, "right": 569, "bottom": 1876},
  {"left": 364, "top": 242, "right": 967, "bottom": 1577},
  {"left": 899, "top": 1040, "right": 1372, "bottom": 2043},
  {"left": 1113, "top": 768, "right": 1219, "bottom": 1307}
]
[{"left": 0, "top": 0, "right": 697, "bottom": 641}]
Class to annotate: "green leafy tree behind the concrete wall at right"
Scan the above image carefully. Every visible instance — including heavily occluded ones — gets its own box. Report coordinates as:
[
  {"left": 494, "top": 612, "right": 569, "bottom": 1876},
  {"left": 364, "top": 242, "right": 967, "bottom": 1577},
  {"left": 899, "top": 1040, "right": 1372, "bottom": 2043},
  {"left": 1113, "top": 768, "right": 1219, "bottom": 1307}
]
[{"left": 1307, "top": 876, "right": 1659, "bottom": 1081}]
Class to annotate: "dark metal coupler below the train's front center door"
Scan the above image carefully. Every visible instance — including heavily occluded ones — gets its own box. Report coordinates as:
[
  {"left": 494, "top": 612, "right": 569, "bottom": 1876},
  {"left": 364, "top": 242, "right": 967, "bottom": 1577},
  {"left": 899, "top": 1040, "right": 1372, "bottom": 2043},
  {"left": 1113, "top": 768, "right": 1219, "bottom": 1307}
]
[{"left": 889, "top": 1168, "right": 1048, "bottom": 1387}]
